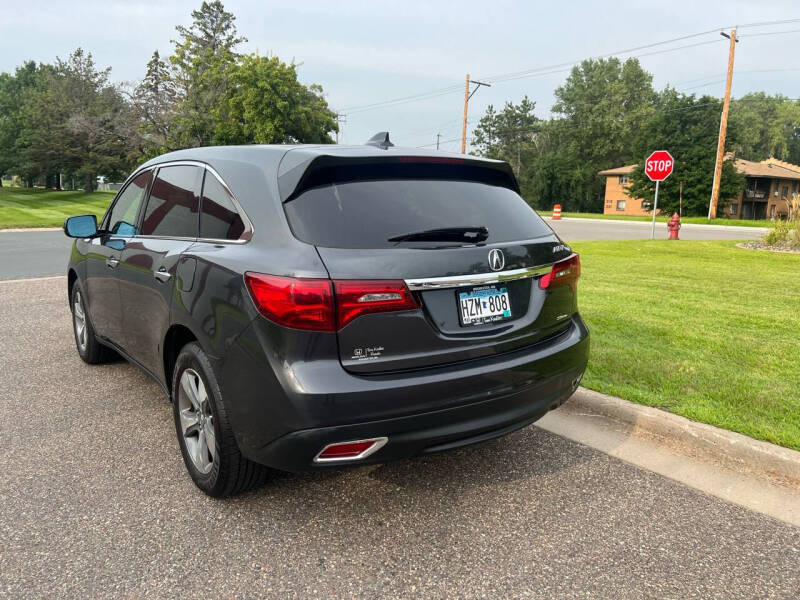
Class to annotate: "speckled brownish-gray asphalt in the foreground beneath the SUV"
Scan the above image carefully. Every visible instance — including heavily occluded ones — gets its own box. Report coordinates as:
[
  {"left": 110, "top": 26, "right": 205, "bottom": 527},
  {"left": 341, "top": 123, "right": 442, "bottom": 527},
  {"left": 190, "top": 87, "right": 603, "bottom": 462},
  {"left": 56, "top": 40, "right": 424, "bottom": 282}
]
[{"left": 0, "top": 278, "right": 800, "bottom": 598}]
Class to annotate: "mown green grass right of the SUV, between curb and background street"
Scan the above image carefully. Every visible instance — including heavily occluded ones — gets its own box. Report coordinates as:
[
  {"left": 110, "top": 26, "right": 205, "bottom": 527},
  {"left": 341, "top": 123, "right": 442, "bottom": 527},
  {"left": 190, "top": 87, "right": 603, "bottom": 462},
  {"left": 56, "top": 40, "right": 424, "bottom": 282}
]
[{"left": 573, "top": 241, "right": 800, "bottom": 450}]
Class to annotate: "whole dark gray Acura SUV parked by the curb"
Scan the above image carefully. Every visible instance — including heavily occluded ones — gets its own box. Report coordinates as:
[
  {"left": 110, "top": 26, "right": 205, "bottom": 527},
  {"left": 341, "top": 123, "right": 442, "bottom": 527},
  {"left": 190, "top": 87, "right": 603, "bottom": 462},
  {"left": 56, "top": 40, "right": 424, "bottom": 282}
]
[{"left": 64, "top": 135, "right": 589, "bottom": 496}]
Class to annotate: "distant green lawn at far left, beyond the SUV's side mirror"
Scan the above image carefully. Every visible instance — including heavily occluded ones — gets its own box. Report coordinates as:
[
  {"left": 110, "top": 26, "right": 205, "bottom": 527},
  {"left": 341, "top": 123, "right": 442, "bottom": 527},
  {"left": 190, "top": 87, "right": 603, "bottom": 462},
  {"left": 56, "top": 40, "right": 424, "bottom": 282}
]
[{"left": 0, "top": 187, "right": 115, "bottom": 229}]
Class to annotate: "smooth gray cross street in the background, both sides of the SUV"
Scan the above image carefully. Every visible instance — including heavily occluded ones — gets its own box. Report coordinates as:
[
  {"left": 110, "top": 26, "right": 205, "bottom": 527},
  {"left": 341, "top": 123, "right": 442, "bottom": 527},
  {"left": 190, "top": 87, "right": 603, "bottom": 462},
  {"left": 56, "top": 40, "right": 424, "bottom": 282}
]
[{"left": 0, "top": 219, "right": 762, "bottom": 279}]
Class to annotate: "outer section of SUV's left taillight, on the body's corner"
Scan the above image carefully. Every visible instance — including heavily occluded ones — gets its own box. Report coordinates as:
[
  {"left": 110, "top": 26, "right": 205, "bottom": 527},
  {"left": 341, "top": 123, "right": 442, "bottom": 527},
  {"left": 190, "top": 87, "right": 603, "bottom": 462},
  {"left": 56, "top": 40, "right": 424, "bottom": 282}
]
[{"left": 244, "top": 273, "right": 336, "bottom": 331}]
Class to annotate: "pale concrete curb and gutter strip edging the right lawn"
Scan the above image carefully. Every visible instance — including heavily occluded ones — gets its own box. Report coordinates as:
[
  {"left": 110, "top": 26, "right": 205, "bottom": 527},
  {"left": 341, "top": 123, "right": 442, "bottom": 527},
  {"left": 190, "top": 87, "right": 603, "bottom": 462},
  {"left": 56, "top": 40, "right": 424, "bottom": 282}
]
[{"left": 537, "top": 388, "right": 800, "bottom": 527}]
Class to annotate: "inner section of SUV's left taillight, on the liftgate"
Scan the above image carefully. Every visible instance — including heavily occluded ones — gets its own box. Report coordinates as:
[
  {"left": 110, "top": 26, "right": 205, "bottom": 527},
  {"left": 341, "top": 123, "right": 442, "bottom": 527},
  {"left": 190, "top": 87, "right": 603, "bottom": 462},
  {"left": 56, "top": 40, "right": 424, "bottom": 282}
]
[{"left": 333, "top": 279, "right": 419, "bottom": 329}]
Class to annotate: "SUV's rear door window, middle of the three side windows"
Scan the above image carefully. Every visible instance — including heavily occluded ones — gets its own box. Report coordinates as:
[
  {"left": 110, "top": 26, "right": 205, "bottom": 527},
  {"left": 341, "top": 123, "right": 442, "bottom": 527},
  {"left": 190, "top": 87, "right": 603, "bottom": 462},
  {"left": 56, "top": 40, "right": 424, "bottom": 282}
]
[{"left": 142, "top": 165, "right": 204, "bottom": 238}]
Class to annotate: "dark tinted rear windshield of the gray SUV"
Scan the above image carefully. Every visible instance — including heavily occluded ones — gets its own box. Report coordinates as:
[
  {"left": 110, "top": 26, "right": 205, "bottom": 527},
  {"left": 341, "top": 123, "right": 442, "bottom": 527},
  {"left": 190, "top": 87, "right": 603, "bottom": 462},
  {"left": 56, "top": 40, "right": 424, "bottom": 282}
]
[{"left": 284, "top": 179, "right": 552, "bottom": 248}]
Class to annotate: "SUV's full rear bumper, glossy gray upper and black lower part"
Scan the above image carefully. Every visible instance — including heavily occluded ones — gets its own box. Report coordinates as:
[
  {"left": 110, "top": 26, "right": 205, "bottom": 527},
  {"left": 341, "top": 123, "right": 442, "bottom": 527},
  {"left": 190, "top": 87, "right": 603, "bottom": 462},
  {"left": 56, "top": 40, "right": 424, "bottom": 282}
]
[{"left": 220, "top": 314, "right": 589, "bottom": 471}]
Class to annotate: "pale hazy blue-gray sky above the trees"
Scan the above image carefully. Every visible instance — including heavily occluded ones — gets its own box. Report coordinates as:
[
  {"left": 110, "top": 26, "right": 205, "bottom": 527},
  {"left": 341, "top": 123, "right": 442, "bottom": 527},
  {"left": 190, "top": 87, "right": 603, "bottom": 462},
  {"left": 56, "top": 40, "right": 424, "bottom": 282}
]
[{"left": 0, "top": 0, "right": 800, "bottom": 151}]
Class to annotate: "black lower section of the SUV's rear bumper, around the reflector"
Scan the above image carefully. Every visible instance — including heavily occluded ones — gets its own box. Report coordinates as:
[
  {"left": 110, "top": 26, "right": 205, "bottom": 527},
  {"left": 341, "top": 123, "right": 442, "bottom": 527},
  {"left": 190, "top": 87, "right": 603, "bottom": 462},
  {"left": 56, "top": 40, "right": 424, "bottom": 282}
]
[{"left": 251, "top": 369, "right": 583, "bottom": 471}]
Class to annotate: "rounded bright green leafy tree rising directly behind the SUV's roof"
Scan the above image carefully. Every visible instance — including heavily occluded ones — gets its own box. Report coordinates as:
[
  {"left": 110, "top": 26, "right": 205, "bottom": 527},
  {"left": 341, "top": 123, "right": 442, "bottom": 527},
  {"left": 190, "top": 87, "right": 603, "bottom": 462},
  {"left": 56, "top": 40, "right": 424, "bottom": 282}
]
[{"left": 219, "top": 54, "right": 338, "bottom": 144}]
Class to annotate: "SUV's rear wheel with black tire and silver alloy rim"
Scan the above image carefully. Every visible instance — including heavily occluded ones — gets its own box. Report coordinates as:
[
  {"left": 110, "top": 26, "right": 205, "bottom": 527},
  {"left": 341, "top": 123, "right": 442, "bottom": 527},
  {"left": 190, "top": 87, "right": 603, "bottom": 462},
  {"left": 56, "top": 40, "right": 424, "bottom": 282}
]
[{"left": 172, "top": 342, "right": 267, "bottom": 498}]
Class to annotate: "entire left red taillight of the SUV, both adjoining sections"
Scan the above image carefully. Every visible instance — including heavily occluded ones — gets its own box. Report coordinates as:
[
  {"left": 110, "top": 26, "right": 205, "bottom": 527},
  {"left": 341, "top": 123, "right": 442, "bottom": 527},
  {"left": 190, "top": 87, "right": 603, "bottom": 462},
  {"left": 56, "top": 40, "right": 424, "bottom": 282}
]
[{"left": 245, "top": 273, "right": 419, "bottom": 331}]
